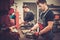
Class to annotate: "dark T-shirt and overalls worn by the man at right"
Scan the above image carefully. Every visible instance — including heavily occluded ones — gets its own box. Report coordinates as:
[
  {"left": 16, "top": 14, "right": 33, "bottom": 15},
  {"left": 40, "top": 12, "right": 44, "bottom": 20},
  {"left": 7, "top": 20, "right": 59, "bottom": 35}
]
[{"left": 39, "top": 10, "right": 54, "bottom": 40}]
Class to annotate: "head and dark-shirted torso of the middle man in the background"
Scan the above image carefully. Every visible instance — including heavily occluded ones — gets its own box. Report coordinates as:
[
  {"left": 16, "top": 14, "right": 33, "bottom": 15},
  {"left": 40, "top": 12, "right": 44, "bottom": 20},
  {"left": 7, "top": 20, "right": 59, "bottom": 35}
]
[{"left": 23, "top": 5, "right": 34, "bottom": 22}]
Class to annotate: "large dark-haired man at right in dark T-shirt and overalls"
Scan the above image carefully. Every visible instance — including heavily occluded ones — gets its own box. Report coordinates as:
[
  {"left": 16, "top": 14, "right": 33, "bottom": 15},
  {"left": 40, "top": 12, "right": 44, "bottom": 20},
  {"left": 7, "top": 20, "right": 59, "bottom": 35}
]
[{"left": 30, "top": 0, "right": 54, "bottom": 40}]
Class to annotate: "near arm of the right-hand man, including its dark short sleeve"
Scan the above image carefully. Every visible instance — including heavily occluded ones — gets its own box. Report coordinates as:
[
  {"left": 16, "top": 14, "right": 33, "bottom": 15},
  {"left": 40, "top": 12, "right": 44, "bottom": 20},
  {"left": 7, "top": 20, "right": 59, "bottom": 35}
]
[{"left": 39, "top": 10, "right": 54, "bottom": 35}]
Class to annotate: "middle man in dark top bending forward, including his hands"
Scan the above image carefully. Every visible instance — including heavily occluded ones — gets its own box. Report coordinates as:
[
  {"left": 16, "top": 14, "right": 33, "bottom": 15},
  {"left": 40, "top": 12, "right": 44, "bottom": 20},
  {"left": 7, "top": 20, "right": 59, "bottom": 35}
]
[{"left": 21, "top": 5, "right": 34, "bottom": 28}]
